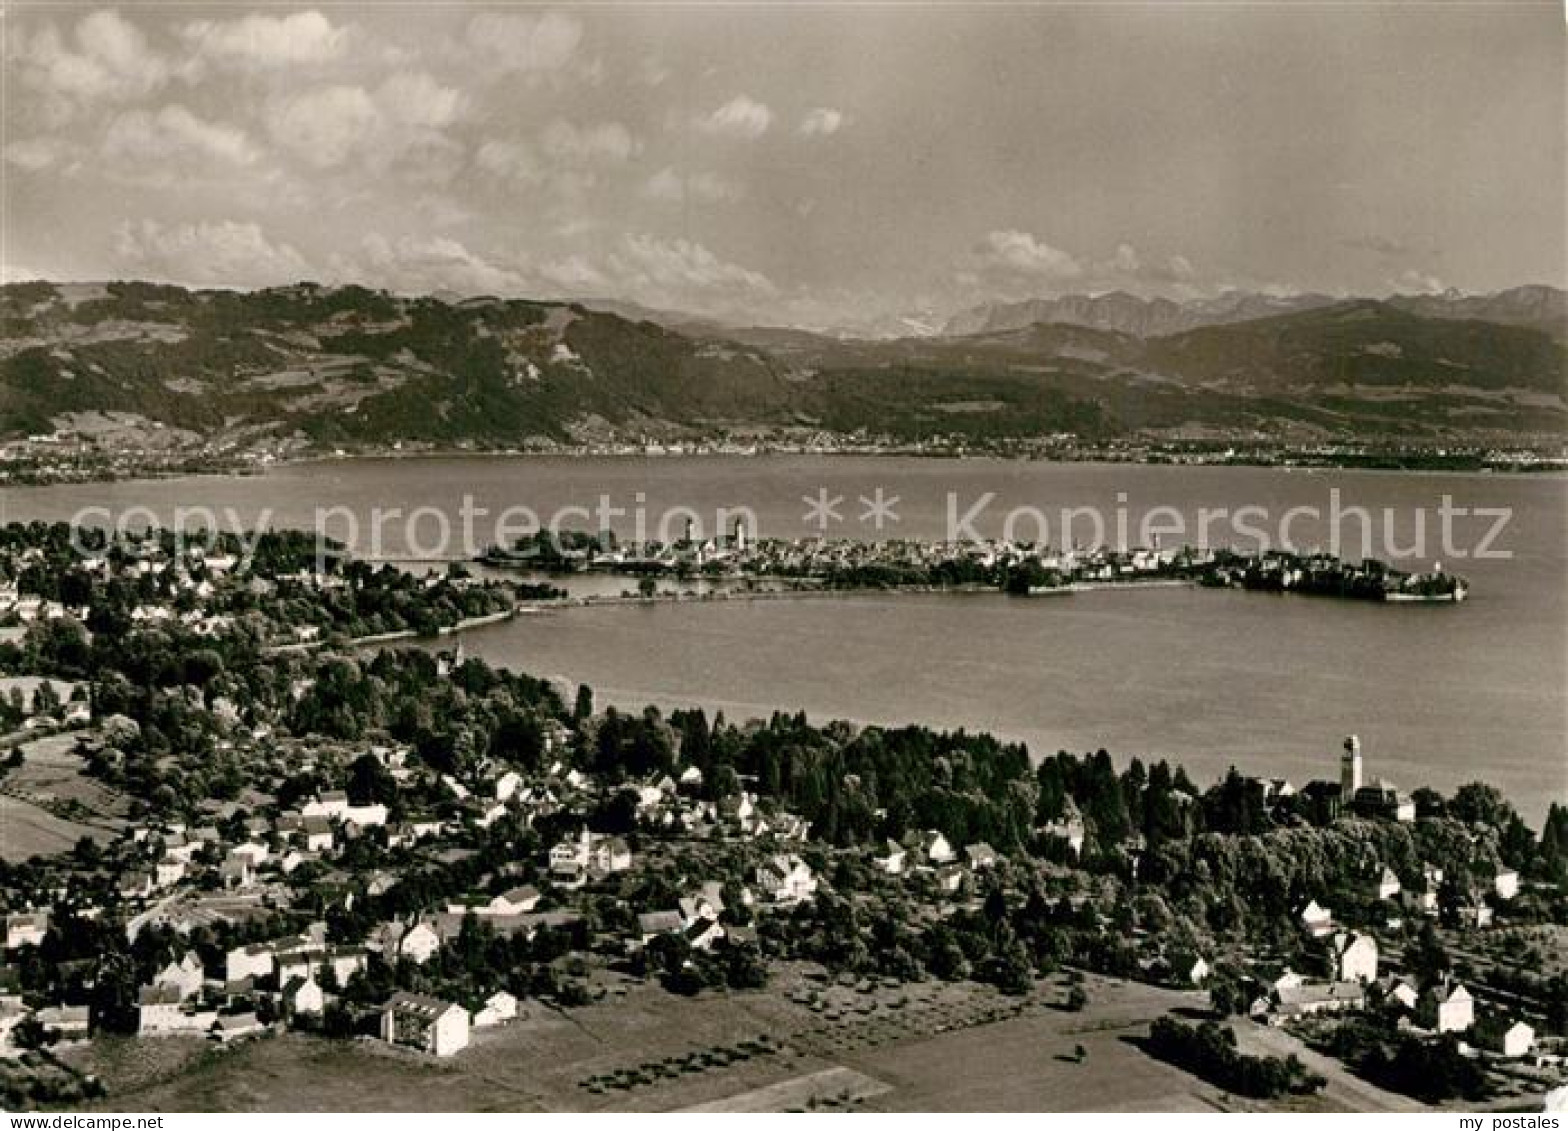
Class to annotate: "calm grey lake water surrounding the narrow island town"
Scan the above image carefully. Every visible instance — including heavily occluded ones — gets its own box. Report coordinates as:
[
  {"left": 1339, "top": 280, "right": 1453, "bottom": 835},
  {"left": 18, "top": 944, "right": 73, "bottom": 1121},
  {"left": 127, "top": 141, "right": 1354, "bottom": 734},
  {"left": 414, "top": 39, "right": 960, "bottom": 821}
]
[{"left": 0, "top": 456, "right": 1568, "bottom": 822}]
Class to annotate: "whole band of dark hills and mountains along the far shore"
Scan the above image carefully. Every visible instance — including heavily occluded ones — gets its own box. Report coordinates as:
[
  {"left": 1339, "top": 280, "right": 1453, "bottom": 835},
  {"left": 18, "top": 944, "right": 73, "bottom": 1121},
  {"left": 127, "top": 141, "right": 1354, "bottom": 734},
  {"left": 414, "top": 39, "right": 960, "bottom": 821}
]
[{"left": 0, "top": 282, "right": 1568, "bottom": 447}]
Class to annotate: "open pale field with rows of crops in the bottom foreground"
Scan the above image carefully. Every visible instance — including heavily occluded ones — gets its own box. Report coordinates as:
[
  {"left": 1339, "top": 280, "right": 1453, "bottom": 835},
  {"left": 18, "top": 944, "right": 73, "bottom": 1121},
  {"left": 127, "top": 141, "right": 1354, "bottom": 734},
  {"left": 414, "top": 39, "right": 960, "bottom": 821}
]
[{"left": 64, "top": 968, "right": 1436, "bottom": 1111}]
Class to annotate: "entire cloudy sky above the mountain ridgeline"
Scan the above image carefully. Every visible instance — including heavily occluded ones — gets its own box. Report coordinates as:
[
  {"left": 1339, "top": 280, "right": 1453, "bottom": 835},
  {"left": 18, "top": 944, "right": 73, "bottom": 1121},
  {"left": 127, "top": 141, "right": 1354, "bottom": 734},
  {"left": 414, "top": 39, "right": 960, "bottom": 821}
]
[{"left": 0, "top": 0, "right": 1568, "bottom": 328}]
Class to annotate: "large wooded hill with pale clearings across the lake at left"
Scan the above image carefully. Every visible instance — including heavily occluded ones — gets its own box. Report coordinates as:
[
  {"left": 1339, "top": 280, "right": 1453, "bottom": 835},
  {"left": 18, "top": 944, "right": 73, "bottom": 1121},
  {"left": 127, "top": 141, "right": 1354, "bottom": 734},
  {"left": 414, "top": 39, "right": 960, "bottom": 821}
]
[{"left": 0, "top": 284, "right": 790, "bottom": 444}]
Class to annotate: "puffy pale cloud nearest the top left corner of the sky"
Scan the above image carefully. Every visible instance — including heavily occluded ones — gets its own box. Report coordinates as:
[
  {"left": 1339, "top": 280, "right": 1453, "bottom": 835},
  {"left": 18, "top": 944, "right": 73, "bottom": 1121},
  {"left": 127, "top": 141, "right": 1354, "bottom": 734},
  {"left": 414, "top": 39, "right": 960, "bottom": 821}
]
[{"left": 6, "top": 11, "right": 169, "bottom": 122}]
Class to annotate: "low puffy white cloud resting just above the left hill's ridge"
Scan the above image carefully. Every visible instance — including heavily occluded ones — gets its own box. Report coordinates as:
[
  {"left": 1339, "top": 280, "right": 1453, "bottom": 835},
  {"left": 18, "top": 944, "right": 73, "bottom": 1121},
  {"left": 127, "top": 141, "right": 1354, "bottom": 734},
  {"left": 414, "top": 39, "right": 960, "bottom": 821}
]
[{"left": 114, "top": 220, "right": 310, "bottom": 287}]
